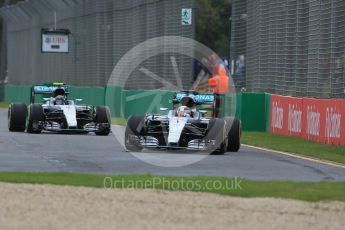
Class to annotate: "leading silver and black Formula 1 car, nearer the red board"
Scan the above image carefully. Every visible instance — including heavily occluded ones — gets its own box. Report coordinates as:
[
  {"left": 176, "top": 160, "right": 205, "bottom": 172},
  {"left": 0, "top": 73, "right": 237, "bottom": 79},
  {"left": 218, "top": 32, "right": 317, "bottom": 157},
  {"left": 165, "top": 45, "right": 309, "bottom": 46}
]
[{"left": 125, "top": 91, "right": 241, "bottom": 154}]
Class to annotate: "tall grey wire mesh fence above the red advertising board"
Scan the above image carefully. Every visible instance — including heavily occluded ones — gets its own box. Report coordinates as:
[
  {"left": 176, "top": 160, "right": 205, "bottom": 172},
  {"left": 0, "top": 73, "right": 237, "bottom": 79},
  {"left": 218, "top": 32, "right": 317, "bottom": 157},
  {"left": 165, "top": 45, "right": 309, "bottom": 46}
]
[{"left": 231, "top": 0, "right": 345, "bottom": 98}]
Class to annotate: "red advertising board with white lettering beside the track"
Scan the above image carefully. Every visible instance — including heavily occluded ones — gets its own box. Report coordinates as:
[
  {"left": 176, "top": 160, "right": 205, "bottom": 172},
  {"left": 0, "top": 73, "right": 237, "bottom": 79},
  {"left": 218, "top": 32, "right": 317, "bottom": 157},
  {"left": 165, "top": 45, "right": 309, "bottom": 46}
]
[{"left": 270, "top": 95, "right": 345, "bottom": 146}]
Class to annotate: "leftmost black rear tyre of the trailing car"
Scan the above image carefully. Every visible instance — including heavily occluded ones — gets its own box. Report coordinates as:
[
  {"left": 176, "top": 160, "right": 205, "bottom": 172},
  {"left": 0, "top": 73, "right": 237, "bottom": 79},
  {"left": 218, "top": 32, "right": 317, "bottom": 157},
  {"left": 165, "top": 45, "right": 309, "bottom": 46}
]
[{"left": 8, "top": 103, "right": 28, "bottom": 132}]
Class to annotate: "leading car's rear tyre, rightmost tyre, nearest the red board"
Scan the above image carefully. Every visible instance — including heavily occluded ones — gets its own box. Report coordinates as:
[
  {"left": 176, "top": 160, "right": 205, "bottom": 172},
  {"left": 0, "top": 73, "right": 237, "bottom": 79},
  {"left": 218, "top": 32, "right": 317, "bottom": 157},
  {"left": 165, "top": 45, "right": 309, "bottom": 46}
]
[{"left": 225, "top": 117, "right": 242, "bottom": 152}]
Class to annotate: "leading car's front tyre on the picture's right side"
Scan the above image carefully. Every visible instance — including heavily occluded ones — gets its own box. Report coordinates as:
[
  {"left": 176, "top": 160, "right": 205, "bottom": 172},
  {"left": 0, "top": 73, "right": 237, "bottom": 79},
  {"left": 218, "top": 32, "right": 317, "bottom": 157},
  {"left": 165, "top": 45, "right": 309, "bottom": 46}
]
[{"left": 206, "top": 118, "right": 228, "bottom": 155}]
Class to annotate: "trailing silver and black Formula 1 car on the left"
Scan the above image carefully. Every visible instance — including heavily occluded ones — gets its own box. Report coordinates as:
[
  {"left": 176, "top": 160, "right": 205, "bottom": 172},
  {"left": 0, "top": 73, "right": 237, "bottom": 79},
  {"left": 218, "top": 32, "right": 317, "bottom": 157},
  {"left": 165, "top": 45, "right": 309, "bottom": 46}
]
[{"left": 8, "top": 83, "right": 111, "bottom": 136}]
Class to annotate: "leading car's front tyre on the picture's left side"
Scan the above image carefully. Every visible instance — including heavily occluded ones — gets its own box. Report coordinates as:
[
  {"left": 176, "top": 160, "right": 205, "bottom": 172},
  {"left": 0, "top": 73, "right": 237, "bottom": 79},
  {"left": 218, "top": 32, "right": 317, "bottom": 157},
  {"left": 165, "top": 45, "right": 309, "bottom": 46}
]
[{"left": 125, "top": 116, "right": 145, "bottom": 152}]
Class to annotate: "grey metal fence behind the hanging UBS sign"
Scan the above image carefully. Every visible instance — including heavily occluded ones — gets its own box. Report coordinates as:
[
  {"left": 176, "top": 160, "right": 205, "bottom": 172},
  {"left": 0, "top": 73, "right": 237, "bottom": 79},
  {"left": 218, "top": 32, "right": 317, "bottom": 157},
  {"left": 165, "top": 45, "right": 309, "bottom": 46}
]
[{"left": 0, "top": 0, "right": 194, "bottom": 89}]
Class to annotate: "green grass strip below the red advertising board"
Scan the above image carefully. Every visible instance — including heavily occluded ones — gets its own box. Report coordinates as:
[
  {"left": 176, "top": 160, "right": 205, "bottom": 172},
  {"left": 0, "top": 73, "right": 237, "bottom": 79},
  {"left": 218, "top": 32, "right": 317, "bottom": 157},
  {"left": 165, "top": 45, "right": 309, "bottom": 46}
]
[{"left": 242, "top": 132, "right": 345, "bottom": 165}]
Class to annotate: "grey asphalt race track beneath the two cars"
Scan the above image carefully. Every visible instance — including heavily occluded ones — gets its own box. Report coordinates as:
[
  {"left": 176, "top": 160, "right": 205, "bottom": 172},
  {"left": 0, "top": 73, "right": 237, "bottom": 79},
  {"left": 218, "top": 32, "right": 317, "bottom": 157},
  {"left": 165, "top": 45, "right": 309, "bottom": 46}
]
[{"left": 0, "top": 109, "right": 345, "bottom": 181}]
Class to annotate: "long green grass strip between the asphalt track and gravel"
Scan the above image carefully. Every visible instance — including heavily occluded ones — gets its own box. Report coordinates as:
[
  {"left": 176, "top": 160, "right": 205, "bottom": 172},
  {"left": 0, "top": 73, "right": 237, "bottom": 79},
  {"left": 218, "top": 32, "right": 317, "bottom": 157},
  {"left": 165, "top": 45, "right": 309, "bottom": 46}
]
[{"left": 0, "top": 172, "right": 345, "bottom": 202}]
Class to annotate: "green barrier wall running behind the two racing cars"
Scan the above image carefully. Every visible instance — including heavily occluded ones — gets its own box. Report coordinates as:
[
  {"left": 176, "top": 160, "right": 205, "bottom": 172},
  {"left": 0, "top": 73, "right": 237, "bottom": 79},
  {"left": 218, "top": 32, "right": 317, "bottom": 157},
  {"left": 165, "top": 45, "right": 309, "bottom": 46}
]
[{"left": 0, "top": 85, "right": 271, "bottom": 132}]
